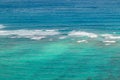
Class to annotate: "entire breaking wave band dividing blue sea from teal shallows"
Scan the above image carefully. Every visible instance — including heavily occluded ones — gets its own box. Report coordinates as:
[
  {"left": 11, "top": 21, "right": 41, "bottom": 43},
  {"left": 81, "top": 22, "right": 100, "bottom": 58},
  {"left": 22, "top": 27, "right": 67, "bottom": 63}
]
[{"left": 0, "top": 24, "right": 120, "bottom": 45}]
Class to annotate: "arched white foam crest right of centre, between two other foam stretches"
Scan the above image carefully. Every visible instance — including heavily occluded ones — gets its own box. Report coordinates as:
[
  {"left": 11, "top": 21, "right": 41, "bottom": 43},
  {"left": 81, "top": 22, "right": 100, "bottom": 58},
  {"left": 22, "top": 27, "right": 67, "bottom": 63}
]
[{"left": 68, "top": 31, "right": 98, "bottom": 38}]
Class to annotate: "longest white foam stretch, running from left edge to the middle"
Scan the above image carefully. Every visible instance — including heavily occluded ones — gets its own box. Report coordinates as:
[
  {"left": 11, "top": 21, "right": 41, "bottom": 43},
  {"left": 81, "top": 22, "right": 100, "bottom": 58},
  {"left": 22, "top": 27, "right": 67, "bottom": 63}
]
[{"left": 0, "top": 29, "right": 60, "bottom": 40}]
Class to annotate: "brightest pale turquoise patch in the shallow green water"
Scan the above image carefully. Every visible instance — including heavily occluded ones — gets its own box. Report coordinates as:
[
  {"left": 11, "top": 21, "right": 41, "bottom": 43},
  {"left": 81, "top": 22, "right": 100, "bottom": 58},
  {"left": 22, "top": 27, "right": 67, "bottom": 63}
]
[{"left": 17, "top": 43, "right": 68, "bottom": 60}]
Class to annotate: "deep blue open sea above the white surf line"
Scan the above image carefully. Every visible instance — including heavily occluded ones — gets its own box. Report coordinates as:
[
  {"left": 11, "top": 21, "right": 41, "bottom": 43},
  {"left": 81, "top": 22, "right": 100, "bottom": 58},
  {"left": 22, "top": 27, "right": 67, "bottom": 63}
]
[{"left": 0, "top": 0, "right": 120, "bottom": 29}]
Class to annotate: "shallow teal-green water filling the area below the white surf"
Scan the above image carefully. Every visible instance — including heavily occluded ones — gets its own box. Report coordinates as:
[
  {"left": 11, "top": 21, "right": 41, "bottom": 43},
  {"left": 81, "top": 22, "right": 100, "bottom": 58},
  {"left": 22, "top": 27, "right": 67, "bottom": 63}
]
[{"left": 0, "top": 31, "right": 120, "bottom": 80}]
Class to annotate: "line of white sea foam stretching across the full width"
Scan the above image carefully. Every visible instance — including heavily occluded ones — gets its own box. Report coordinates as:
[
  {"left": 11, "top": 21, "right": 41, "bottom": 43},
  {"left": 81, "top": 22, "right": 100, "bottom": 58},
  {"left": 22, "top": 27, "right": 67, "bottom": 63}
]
[{"left": 0, "top": 24, "right": 120, "bottom": 43}]
